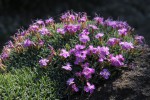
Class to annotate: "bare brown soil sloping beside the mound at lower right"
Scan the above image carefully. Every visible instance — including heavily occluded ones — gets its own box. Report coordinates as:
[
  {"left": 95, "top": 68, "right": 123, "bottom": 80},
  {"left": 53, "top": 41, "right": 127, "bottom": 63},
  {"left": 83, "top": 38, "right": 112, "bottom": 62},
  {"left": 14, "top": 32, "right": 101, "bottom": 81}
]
[{"left": 71, "top": 45, "right": 150, "bottom": 100}]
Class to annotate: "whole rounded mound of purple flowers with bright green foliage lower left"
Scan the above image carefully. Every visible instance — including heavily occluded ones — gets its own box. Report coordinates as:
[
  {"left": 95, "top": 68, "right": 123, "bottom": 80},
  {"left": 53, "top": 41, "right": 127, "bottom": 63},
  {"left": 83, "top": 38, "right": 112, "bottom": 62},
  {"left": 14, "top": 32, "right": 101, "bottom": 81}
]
[{"left": 0, "top": 12, "right": 143, "bottom": 100}]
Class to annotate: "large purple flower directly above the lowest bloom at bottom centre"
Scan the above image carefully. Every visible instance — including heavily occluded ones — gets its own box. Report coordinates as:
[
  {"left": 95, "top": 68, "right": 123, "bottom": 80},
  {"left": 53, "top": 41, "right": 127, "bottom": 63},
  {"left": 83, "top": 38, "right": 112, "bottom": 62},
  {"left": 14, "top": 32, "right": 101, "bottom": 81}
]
[{"left": 82, "top": 67, "right": 95, "bottom": 79}]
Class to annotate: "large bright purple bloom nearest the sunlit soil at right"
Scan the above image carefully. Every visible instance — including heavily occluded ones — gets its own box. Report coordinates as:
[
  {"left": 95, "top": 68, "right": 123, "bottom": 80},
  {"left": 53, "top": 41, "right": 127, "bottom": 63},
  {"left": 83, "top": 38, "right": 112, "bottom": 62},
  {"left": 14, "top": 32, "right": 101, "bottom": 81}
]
[{"left": 110, "top": 54, "right": 124, "bottom": 67}]
